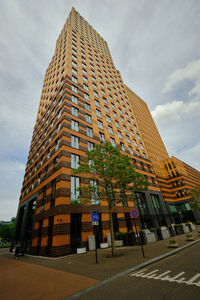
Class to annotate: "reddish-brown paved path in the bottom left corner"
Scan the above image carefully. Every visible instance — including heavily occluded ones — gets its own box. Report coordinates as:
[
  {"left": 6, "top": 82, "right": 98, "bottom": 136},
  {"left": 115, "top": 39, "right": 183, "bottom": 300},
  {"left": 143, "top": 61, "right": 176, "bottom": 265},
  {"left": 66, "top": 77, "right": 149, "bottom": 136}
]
[{"left": 0, "top": 256, "right": 98, "bottom": 300}]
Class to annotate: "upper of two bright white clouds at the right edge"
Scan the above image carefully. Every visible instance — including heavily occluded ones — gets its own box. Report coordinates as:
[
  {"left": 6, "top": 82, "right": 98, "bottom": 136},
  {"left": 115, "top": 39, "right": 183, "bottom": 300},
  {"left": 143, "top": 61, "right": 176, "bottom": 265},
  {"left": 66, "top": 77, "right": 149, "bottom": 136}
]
[{"left": 162, "top": 59, "right": 200, "bottom": 96}]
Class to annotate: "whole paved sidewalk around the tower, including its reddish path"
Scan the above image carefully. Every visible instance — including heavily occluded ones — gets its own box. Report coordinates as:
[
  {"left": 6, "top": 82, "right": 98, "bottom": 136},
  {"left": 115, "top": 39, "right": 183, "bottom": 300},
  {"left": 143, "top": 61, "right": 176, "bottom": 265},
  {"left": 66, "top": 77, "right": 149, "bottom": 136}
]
[{"left": 0, "top": 226, "right": 200, "bottom": 300}]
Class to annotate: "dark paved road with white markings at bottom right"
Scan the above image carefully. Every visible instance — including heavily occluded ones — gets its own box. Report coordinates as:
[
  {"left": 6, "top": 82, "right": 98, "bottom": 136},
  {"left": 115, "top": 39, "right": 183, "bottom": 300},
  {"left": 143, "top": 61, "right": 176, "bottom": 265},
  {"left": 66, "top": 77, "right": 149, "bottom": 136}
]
[{"left": 78, "top": 244, "right": 200, "bottom": 300}]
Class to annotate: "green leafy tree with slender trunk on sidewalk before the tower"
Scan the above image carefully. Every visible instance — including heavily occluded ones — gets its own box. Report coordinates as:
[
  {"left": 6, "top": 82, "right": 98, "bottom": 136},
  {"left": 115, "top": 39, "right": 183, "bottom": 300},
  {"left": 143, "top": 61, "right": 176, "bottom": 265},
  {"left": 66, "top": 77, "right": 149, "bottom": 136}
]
[{"left": 72, "top": 142, "right": 148, "bottom": 256}]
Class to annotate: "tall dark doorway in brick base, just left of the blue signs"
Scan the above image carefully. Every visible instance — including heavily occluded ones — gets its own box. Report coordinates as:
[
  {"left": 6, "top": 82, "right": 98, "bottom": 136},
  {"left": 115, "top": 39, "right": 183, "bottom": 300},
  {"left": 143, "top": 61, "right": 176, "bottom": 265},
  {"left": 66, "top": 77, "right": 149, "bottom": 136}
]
[{"left": 70, "top": 214, "right": 82, "bottom": 253}]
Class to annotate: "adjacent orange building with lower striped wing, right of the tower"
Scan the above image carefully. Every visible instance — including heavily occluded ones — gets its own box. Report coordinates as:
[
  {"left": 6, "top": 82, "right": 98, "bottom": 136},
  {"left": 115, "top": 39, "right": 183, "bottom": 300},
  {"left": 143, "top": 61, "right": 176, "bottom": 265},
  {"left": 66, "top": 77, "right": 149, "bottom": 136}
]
[{"left": 126, "top": 86, "right": 200, "bottom": 223}]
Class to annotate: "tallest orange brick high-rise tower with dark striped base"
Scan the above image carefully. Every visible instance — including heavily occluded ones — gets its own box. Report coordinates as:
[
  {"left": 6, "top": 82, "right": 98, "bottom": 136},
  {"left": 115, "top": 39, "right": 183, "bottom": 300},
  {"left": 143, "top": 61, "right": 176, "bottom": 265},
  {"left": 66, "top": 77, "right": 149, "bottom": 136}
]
[{"left": 15, "top": 8, "right": 198, "bottom": 256}]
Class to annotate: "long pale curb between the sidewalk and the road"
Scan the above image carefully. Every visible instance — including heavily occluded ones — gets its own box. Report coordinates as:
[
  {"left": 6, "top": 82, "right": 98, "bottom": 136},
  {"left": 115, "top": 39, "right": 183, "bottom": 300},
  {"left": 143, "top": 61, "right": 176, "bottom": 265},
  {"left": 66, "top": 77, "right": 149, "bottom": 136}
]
[{"left": 63, "top": 239, "right": 200, "bottom": 300}]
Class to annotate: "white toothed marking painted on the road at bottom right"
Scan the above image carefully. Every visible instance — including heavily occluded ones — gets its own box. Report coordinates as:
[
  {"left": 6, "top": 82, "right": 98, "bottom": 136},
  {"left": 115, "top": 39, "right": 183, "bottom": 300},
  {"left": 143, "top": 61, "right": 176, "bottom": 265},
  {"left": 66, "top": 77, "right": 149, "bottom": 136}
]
[{"left": 130, "top": 269, "right": 200, "bottom": 287}]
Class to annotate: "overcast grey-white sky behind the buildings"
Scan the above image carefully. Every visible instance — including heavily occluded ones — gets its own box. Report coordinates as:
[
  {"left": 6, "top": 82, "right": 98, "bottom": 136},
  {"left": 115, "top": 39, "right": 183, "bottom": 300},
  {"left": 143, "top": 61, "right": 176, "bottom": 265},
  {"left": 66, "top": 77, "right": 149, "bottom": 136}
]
[{"left": 0, "top": 0, "right": 200, "bottom": 220}]
